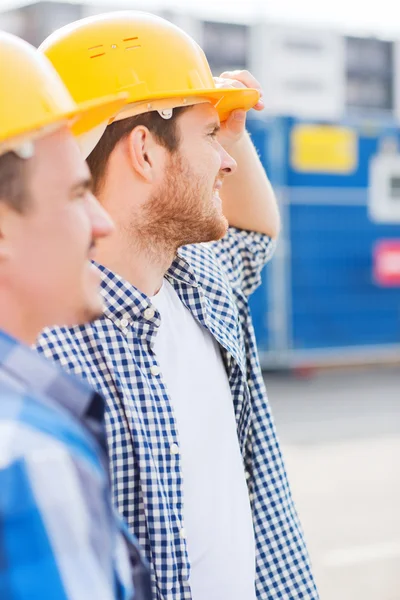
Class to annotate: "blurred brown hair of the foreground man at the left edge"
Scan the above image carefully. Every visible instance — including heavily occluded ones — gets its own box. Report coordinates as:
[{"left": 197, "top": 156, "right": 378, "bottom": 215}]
[{"left": 0, "top": 152, "right": 29, "bottom": 213}]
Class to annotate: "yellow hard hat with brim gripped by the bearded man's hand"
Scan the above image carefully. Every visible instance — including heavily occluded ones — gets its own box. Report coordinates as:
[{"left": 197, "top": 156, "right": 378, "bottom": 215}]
[{"left": 39, "top": 11, "right": 260, "bottom": 121}]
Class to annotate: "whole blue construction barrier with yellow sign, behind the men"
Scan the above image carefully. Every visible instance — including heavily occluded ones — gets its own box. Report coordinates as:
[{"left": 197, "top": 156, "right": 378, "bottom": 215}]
[{"left": 245, "top": 118, "right": 400, "bottom": 366}]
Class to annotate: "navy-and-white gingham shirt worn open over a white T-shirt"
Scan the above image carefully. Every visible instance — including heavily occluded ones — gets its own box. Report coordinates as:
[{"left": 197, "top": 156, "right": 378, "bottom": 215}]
[{"left": 39, "top": 228, "right": 318, "bottom": 600}]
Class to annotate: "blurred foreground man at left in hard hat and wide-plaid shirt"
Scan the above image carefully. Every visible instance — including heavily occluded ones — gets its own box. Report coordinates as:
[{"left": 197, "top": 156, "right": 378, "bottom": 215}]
[{"left": 0, "top": 32, "right": 150, "bottom": 600}]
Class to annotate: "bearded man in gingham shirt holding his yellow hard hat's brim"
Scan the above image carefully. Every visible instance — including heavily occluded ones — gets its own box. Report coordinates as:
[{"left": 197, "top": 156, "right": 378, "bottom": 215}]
[{"left": 39, "top": 11, "right": 318, "bottom": 600}]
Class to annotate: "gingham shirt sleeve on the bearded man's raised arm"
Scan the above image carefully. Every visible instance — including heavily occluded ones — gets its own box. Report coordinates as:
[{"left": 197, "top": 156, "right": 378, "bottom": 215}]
[{"left": 208, "top": 227, "right": 276, "bottom": 296}]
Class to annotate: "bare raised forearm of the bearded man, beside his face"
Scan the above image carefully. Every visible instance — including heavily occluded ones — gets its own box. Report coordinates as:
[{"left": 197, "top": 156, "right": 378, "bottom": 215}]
[{"left": 221, "top": 132, "right": 280, "bottom": 238}]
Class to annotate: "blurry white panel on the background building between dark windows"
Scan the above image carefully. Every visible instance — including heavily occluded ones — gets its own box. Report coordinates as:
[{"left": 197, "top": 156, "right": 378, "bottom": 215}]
[{"left": 249, "top": 23, "right": 345, "bottom": 120}]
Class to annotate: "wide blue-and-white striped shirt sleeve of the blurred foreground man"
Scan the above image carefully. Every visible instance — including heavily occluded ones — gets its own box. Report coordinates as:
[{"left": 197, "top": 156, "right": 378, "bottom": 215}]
[{"left": 0, "top": 444, "right": 125, "bottom": 600}]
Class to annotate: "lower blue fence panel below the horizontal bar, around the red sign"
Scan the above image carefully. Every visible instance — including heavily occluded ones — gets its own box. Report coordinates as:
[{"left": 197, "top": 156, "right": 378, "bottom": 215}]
[{"left": 290, "top": 205, "right": 400, "bottom": 349}]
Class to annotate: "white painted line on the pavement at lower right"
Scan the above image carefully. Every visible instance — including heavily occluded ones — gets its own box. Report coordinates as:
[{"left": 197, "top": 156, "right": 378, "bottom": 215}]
[{"left": 322, "top": 540, "right": 400, "bottom": 567}]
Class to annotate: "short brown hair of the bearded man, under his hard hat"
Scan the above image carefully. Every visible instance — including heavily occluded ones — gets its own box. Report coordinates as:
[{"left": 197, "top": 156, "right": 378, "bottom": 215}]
[{"left": 87, "top": 106, "right": 190, "bottom": 193}]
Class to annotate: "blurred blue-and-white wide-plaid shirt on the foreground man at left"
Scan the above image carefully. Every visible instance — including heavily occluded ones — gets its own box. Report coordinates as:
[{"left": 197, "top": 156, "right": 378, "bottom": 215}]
[{"left": 0, "top": 332, "right": 139, "bottom": 600}]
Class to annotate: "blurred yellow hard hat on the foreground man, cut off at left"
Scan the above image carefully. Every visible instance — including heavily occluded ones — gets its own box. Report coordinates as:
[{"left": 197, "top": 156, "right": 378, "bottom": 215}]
[{"left": 0, "top": 32, "right": 126, "bottom": 153}]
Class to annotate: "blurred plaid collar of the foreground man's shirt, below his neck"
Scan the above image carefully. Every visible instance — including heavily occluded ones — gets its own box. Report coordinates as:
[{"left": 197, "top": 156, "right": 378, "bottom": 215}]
[{"left": 0, "top": 330, "right": 104, "bottom": 447}]
